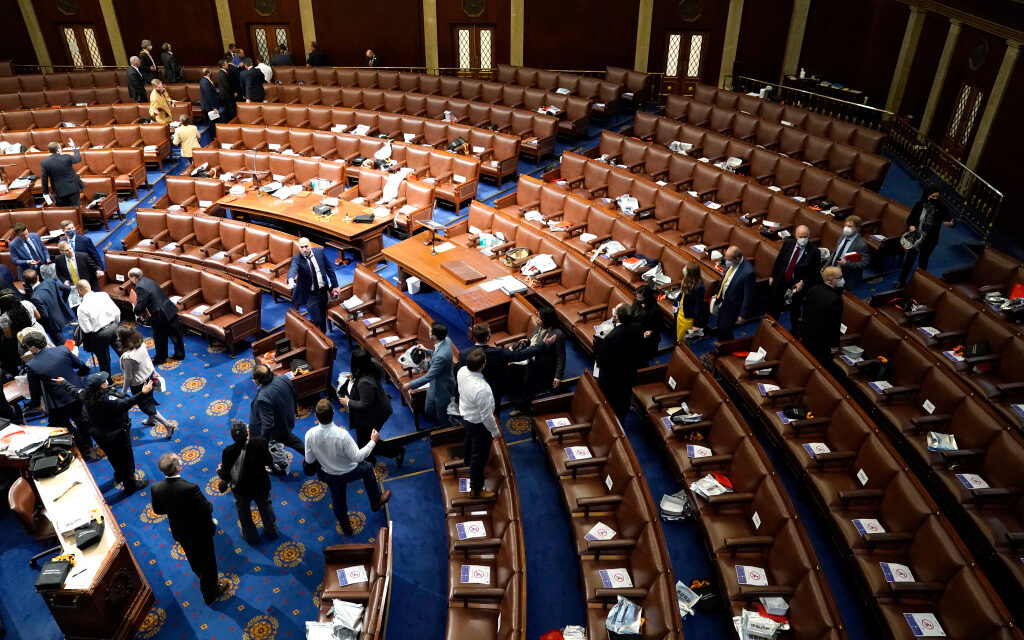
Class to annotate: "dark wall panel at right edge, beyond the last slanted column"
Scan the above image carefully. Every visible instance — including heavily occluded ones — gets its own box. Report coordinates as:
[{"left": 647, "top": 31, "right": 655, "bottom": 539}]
[{"left": 978, "top": 60, "right": 1024, "bottom": 246}]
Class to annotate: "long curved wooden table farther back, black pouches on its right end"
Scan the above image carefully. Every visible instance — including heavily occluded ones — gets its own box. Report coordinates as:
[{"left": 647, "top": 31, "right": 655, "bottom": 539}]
[{"left": 217, "top": 190, "right": 394, "bottom": 263}]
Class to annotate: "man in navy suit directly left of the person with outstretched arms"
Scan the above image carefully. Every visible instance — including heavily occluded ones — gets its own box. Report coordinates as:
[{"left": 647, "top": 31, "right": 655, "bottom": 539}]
[{"left": 23, "top": 332, "right": 92, "bottom": 456}]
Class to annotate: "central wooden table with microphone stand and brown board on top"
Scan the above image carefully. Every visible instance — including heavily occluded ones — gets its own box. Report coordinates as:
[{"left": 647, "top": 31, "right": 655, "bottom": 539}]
[{"left": 384, "top": 233, "right": 510, "bottom": 326}]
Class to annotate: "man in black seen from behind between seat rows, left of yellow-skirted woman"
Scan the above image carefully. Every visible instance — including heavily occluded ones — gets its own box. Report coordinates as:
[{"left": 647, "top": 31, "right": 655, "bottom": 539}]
[{"left": 595, "top": 302, "right": 643, "bottom": 422}]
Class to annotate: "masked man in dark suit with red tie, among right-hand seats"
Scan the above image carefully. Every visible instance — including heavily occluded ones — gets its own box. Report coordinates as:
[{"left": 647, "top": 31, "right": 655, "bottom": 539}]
[{"left": 768, "top": 224, "right": 821, "bottom": 336}]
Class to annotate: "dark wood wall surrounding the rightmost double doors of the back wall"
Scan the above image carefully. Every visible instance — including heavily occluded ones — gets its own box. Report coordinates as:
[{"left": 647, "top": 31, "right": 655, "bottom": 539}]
[{"left": 647, "top": 0, "right": 733, "bottom": 85}]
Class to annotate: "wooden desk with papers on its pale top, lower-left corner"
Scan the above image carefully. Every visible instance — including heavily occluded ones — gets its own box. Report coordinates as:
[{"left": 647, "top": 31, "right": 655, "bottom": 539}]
[{"left": 0, "top": 427, "right": 154, "bottom": 640}]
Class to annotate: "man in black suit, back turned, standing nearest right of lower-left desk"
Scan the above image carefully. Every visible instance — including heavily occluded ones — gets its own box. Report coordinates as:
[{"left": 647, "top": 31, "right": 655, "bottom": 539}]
[{"left": 150, "top": 454, "right": 231, "bottom": 604}]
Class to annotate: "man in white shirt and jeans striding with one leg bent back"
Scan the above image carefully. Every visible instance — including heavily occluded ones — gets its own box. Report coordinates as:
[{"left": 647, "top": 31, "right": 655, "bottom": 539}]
[{"left": 302, "top": 399, "right": 391, "bottom": 536}]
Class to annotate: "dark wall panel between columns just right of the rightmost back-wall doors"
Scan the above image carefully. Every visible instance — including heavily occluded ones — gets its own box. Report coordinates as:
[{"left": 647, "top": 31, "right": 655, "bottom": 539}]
[{"left": 733, "top": 0, "right": 793, "bottom": 82}]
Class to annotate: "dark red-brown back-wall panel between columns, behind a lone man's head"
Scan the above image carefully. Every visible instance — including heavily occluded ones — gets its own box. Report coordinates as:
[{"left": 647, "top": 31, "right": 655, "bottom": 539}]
[{"left": 313, "top": 0, "right": 425, "bottom": 67}]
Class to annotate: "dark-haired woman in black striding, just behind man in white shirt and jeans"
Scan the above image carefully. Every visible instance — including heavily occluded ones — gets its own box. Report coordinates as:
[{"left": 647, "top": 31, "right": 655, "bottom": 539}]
[{"left": 338, "top": 349, "right": 406, "bottom": 467}]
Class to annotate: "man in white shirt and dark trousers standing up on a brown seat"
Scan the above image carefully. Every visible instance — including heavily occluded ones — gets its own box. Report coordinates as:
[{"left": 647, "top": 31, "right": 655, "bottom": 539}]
[{"left": 456, "top": 348, "right": 502, "bottom": 498}]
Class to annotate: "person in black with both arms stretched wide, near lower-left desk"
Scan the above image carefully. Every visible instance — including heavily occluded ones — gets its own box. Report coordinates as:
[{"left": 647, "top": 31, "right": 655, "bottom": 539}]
[{"left": 53, "top": 371, "right": 153, "bottom": 494}]
